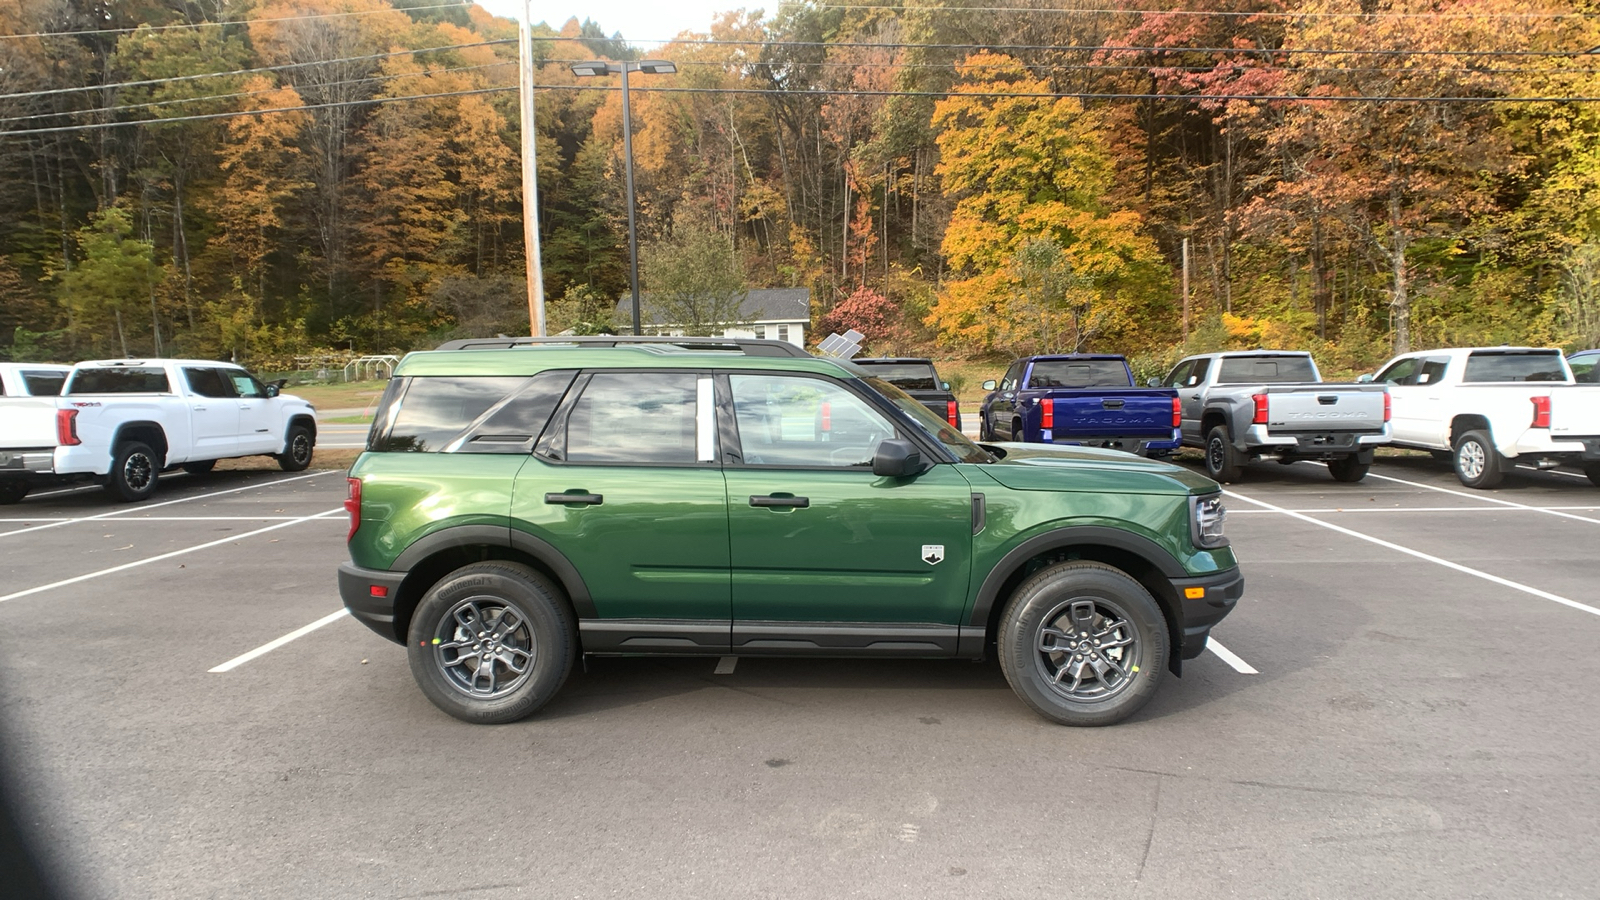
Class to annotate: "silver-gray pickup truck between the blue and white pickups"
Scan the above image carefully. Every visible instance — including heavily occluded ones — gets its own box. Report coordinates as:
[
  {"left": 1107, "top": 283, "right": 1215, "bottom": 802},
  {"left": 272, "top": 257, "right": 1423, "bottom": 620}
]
[{"left": 1163, "top": 351, "right": 1389, "bottom": 482}]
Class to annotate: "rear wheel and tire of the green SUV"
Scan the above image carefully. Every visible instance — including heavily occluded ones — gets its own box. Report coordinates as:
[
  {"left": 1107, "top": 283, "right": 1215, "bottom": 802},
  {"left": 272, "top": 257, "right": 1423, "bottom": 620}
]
[{"left": 406, "top": 562, "right": 578, "bottom": 725}]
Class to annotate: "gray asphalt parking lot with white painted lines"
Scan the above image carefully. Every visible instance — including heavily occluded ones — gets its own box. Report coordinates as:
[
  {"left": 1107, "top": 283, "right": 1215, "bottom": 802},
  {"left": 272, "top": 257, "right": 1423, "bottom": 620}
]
[{"left": 0, "top": 458, "right": 1600, "bottom": 898}]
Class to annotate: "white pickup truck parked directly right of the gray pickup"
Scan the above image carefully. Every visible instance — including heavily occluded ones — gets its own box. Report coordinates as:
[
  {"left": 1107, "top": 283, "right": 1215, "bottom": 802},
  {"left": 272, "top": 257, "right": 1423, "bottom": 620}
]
[{"left": 1362, "top": 348, "right": 1600, "bottom": 488}]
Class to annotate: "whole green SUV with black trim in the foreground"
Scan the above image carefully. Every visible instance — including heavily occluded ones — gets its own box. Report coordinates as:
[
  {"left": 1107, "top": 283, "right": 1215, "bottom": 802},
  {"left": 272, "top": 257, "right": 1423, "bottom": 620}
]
[{"left": 339, "top": 344, "right": 1243, "bottom": 725}]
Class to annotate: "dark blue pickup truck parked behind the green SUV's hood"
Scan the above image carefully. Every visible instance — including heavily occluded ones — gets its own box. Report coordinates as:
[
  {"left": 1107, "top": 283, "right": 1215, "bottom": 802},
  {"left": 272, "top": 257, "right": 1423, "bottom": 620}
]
[{"left": 978, "top": 354, "right": 1182, "bottom": 456}]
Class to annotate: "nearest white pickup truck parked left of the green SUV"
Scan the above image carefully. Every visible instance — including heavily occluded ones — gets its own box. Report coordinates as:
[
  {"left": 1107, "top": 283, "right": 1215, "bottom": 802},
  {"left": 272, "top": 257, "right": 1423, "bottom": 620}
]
[{"left": 0, "top": 359, "right": 317, "bottom": 503}]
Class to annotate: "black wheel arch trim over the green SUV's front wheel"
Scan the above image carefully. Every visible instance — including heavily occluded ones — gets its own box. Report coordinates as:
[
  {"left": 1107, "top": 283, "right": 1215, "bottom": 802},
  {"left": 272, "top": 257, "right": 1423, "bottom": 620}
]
[{"left": 966, "top": 525, "right": 1189, "bottom": 674}]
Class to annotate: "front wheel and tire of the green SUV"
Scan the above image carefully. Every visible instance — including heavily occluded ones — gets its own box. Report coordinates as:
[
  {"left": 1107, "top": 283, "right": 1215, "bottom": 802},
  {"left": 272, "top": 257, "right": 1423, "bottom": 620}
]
[{"left": 997, "top": 562, "right": 1170, "bottom": 725}]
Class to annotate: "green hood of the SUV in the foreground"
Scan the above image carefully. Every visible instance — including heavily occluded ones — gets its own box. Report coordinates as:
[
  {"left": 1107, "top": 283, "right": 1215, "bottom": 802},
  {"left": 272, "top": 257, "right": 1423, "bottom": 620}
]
[{"left": 976, "top": 444, "right": 1221, "bottom": 495}]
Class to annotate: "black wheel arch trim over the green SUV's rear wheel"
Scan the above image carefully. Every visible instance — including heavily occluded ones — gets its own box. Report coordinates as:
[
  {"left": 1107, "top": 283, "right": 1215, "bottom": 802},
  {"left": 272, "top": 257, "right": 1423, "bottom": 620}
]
[{"left": 390, "top": 525, "right": 595, "bottom": 644}]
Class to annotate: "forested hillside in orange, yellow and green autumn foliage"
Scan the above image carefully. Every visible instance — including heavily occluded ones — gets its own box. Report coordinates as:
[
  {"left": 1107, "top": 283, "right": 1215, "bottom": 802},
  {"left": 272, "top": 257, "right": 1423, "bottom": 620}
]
[{"left": 0, "top": 0, "right": 1600, "bottom": 368}]
